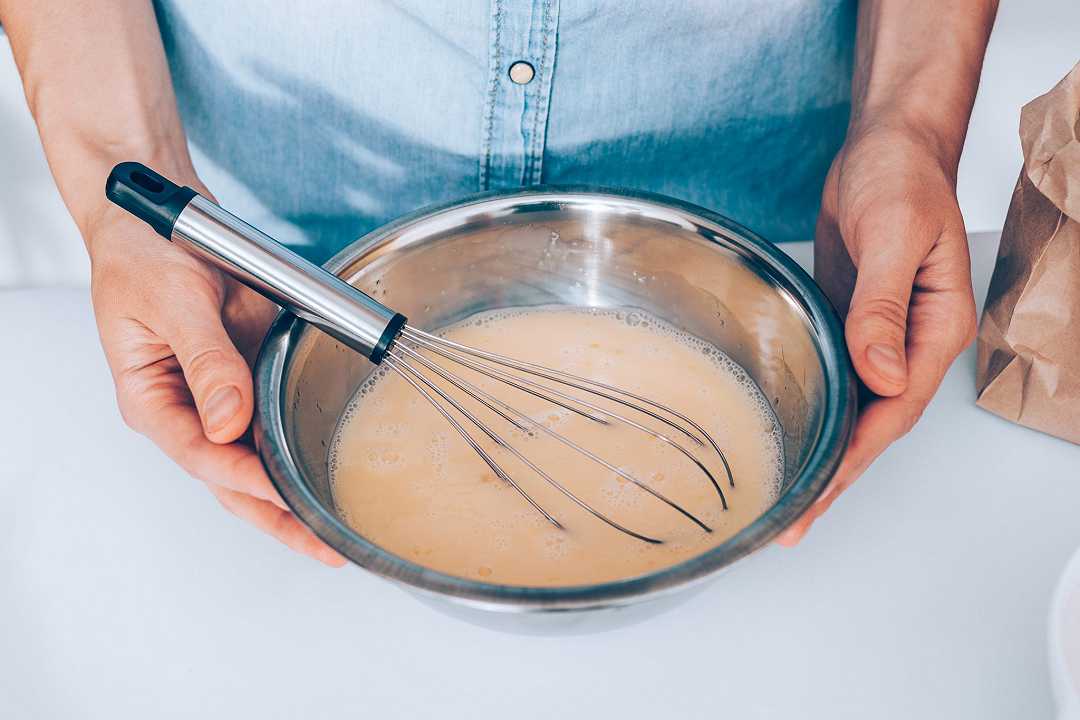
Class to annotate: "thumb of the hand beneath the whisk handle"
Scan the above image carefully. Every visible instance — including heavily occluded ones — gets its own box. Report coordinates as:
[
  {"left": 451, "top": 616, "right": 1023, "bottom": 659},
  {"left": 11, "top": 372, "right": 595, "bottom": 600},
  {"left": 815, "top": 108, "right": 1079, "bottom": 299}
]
[{"left": 168, "top": 303, "right": 254, "bottom": 444}]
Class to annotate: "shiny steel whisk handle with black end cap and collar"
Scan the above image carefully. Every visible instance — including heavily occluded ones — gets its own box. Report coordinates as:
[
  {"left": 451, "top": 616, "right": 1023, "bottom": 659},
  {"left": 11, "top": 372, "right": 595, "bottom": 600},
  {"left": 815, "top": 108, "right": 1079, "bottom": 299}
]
[{"left": 105, "top": 162, "right": 406, "bottom": 363}]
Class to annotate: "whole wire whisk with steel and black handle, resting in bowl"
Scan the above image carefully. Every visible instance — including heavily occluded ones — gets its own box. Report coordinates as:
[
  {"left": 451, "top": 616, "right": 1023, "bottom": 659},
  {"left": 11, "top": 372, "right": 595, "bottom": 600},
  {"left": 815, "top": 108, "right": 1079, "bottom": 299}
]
[{"left": 106, "top": 162, "right": 734, "bottom": 544}]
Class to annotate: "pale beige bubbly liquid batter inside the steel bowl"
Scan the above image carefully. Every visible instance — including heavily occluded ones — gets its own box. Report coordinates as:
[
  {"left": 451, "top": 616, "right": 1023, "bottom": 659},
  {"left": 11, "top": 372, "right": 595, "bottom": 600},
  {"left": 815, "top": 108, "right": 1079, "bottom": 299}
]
[{"left": 330, "top": 308, "right": 782, "bottom": 586}]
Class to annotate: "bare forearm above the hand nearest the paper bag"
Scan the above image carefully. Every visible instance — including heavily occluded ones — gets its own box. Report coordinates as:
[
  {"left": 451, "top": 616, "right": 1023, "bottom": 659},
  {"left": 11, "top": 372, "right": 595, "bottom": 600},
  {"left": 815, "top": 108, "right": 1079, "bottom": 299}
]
[{"left": 851, "top": 0, "right": 998, "bottom": 174}]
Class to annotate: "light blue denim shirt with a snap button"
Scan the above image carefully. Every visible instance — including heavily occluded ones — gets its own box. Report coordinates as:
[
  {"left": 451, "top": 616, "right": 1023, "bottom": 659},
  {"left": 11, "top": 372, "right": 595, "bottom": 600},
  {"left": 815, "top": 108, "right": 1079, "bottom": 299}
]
[{"left": 154, "top": 0, "right": 855, "bottom": 261}]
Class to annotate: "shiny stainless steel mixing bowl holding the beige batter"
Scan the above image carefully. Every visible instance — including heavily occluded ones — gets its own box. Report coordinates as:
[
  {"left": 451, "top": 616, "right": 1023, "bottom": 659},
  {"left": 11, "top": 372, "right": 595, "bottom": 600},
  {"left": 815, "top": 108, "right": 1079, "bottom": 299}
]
[{"left": 255, "top": 188, "right": 855, "bottom": 629}]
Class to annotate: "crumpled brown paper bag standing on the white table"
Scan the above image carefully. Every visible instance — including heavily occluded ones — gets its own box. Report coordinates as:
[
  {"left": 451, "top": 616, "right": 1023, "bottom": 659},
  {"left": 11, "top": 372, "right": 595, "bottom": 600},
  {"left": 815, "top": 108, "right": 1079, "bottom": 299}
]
[{"left": 975, "top": 64, "right": 1080, "bottom": 443}]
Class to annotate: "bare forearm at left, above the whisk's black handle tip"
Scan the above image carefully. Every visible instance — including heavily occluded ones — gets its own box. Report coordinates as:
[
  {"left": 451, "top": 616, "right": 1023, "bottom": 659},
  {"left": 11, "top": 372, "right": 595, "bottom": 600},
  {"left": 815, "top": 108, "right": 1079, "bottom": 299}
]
[{"left": 0, "top": 0, "right": 193, "bottom": 249}]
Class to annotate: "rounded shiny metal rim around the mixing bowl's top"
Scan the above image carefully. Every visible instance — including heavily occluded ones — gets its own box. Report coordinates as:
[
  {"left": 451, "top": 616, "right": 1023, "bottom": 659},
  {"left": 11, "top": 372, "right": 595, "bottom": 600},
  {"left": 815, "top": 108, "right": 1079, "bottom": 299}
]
[{"left": 253, "top": 186, "right": 855, "bottom": 611}]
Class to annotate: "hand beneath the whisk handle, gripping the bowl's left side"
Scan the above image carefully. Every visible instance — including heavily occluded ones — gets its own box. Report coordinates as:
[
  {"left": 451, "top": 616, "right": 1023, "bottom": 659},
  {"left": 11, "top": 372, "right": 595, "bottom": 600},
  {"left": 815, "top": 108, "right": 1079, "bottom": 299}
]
[{"left": 86, "top": 182, "right": 345, "bottom": 567}]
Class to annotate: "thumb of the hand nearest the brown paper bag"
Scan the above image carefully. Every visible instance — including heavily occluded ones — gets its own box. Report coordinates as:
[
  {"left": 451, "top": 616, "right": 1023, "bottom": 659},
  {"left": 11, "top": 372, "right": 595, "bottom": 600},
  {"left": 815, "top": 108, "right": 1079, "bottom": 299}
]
[{"left": 845, "top": 248, "right": 918, "bottom": 396}]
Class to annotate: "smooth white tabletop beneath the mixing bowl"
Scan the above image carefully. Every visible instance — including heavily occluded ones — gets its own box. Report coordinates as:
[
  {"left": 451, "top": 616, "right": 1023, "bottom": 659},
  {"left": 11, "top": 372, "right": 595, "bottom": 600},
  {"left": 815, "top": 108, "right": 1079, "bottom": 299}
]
[{"left": 0, "top": 235, "right": 1080, "bottom": 719}]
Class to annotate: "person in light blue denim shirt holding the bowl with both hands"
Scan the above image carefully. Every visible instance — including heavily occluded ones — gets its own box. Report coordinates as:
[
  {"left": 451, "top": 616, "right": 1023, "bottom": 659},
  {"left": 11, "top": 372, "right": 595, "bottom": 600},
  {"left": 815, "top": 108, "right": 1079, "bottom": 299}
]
[{"left": 0, "top": 0, "right": 997, "bottom": 565}]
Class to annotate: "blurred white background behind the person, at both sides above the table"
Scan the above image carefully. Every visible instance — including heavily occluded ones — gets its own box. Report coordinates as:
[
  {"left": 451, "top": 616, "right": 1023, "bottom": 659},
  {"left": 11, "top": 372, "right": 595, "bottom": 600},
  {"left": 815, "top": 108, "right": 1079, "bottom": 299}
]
[{"left": 0, "top": 0, "right": 1080, "bottom": 287}]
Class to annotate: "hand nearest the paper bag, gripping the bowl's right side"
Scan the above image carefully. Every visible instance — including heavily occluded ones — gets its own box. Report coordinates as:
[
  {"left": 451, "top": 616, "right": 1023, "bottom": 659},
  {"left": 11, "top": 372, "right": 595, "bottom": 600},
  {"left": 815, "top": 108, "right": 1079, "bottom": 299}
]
[{"left": 778, "top": 125, "right": 976, "bottom": 545}]
